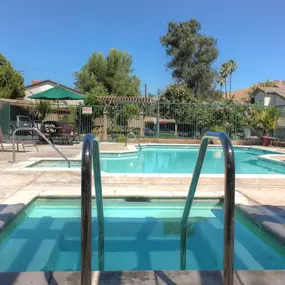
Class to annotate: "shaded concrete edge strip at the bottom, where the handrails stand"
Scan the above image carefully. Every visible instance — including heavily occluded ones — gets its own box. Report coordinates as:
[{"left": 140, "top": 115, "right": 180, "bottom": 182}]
[{"left": 0, "top": 270, "right": 285, "bottom": 285}]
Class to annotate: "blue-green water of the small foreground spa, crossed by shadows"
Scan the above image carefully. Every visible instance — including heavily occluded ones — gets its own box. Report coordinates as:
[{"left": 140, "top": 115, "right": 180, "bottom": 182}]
[{"left": 0, "top": 200, "right": 285, "bottom": 272}]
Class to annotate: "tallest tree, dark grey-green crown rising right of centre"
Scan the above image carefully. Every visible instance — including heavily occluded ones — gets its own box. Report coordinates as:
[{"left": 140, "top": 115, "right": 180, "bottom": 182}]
[{"left": 160, "top": 19, "right": 218, "bottom": 97}]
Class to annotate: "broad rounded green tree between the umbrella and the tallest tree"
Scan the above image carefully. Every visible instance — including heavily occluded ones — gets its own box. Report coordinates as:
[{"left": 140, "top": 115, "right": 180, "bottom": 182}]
[{"left": 74, "top": 49, "right": 140, "bottom": 100}]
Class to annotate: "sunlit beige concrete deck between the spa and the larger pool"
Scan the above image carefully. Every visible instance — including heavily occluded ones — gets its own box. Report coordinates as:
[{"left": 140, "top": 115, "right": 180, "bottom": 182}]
[{"left": 0, "top": 143, "right": 285, "bottom": 206}]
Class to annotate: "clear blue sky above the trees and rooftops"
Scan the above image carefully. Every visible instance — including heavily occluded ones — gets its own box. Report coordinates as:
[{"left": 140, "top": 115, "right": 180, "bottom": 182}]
[{"left": 0, "top": 0, "right": 285, "bottom": 93}]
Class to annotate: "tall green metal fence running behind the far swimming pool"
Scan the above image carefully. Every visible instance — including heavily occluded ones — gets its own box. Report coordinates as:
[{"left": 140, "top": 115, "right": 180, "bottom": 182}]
[{"left": 0, "top": 102, "right": 278, "bottom": 141}]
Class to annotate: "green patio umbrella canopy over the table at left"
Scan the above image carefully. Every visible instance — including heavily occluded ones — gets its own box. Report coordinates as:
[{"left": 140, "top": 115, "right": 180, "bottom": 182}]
[{"left": 29, "top": 86, "right": 84, "bottom": 100}]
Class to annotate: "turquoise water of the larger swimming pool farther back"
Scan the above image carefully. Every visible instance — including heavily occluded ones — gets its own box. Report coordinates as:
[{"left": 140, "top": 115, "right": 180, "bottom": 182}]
[{"left": 27, "top": 146, "right": 285, "bottom": 174}]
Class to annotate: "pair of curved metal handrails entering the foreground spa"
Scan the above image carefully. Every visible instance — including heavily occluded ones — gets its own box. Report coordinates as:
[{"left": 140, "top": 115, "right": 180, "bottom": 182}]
[{"left": 81, "top": 132, "right": 235, "bottom": 285}]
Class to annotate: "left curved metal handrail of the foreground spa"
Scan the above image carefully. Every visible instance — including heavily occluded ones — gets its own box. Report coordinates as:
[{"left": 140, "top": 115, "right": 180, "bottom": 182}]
[{"left": 81, "top": 134, "right": 104, "bottom": 285}]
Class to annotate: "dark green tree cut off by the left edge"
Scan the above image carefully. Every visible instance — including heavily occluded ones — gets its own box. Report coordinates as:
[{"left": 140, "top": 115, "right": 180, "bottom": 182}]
[{"left": 0, "top": 53, "right": 25, "bottom": 99}]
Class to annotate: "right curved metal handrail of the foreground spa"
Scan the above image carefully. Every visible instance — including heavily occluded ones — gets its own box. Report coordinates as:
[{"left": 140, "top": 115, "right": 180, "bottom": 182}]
[{"left": 180, "top": 132, "right": 235, "bottom": 285}]
